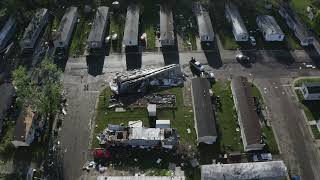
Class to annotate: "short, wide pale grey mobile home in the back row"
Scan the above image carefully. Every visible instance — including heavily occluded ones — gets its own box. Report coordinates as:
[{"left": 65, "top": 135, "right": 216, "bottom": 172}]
[{"left": 256, "top": 15, "right": 284, "bottom": 41}]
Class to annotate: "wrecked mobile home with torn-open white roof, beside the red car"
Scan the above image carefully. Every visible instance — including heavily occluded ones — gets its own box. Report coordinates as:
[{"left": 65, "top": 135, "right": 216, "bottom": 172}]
[{"left": 97, "top": 123, "right": 179, "bottom": 149}]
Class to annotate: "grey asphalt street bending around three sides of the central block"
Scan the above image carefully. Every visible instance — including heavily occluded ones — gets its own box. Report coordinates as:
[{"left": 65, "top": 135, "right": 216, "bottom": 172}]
[{"left": 61, "top": 46, "right": 320, "bottom": 180}]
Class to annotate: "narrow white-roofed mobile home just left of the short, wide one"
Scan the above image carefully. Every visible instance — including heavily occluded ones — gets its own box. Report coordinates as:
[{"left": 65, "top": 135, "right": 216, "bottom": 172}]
[{"left": 225, "top": 2, "right": 249, "bottom": 41}]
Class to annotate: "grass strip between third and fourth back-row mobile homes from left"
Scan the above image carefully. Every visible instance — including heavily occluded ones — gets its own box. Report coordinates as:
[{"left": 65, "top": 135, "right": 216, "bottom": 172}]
[{"left": 69, "top": 13, "right": 93, "bottom": 56}]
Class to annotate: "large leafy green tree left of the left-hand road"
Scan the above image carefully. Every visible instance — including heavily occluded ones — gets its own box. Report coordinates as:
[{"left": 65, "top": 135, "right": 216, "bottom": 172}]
[{"left": 13, "top": 58, "right": 62, "bottom": 116}]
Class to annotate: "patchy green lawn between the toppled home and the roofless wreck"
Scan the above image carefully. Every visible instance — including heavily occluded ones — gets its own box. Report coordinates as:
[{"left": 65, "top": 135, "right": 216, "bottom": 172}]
[{"left": 92, "top": 87, "right": 196, "bottom": 148}]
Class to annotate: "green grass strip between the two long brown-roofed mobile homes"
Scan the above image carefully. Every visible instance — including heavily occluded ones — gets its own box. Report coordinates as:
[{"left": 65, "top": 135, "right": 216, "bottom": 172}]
[{"left": 212, "top": 82, "right": 243, "bottom": 152}]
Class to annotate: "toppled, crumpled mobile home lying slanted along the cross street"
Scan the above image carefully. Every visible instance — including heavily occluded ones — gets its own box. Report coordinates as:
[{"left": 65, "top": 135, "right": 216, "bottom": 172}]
[{"left": 110, "top": 64, "right": 183, "bottom": 94}]
